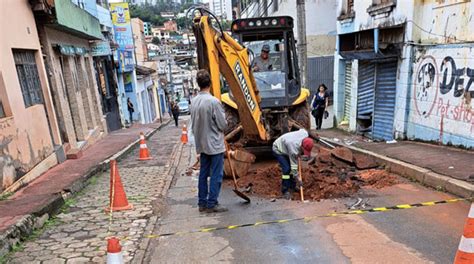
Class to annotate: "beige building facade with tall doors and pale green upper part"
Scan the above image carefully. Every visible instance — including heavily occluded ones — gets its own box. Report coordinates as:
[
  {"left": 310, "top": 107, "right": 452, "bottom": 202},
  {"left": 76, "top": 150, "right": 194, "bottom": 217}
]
[{"left": 30, "top": 0, "right": 107, "bottom": 158}]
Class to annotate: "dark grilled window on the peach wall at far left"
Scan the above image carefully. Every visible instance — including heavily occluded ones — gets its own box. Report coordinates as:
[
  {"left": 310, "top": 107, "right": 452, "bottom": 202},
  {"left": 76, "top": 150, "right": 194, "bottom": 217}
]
[{"left": 13, "top": 50, "right": 43, "bottom": 107}]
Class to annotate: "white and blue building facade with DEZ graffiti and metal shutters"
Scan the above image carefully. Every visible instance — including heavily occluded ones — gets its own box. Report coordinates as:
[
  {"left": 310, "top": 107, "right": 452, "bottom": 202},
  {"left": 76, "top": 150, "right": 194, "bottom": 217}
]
[{"left": 334, "top": 0, "right": 474, "bottom": 148}]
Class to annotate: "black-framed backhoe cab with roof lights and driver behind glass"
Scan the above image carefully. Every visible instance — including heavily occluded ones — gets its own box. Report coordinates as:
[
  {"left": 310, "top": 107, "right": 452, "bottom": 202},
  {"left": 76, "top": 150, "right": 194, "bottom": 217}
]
[{"left": 231, "top": 16, "right": 301, "bottom": 108}]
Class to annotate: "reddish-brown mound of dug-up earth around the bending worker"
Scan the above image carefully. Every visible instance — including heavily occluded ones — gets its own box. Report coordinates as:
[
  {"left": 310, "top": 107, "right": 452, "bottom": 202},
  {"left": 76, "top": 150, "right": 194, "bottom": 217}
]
[{"left": 226, "top": 145, "right": 398, "bottom": 201}]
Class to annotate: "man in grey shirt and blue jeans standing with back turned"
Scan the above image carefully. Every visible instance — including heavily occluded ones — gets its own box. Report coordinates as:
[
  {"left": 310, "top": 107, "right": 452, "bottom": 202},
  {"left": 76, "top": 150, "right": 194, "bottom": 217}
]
[{"left": 191, "top": 70, "right": 231, "bottom": 213}]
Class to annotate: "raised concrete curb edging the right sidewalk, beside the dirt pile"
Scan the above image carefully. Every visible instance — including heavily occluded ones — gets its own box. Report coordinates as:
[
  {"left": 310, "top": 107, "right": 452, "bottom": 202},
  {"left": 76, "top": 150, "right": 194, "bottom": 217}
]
[{"left": 322, "top": 137, "right": 474, "bottom": 198}]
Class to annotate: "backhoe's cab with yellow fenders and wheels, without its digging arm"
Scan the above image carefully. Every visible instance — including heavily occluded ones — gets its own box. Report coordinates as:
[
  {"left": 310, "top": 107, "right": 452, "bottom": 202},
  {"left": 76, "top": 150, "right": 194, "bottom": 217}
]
[{"left": 222, "top": 16, "right": 310, "bottom": 139}]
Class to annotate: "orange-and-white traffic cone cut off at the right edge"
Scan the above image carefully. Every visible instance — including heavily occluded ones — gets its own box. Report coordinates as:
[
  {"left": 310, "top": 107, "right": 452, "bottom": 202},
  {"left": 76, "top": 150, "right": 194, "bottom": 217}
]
[{"left": 454, "top": 203, "right": 474, "bottom": 264}]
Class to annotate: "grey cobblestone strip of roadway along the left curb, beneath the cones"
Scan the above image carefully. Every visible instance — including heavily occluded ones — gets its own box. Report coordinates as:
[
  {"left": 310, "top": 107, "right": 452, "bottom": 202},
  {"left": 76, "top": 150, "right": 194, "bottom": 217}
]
[{"left": 8, "top": 120, "right": 186, "bottom": 263}]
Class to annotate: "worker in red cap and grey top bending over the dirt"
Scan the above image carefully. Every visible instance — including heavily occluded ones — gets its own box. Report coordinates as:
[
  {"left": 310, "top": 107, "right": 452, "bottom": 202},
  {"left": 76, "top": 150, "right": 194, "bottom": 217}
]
[{"left": 272, "top": 129, "right": 313, "bottom": 200}]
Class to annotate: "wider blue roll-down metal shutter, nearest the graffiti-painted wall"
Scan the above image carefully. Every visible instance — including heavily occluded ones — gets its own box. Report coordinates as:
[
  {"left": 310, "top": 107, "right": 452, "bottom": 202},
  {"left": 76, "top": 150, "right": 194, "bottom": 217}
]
[{"left": 372, "top": 61, "right": 397, "bottom": 140}]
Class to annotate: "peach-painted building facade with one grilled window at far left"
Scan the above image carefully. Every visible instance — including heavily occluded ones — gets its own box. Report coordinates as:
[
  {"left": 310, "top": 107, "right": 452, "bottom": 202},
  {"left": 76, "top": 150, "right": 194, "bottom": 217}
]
[{"left": 0, "top": 0, "right": 65, "bottom": 193}]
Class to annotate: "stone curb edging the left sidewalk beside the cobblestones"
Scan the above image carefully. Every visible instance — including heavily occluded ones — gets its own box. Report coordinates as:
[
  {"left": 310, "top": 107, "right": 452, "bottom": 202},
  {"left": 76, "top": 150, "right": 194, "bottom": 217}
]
[{"left": 0, "top": 119, "right": 171, "bottom": 257}]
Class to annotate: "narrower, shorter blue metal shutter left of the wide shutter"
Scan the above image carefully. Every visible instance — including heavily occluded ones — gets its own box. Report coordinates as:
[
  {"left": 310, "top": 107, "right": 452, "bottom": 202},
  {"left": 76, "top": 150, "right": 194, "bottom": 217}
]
[{"left": 357, "top": 62, "right": 375, "bottom": 118}]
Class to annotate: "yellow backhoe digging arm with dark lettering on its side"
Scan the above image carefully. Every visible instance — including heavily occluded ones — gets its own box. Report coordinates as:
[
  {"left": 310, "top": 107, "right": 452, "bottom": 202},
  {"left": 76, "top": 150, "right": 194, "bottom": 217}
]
[{"left": 193, "top": 15, "right": 269, "bottom": 141}]
